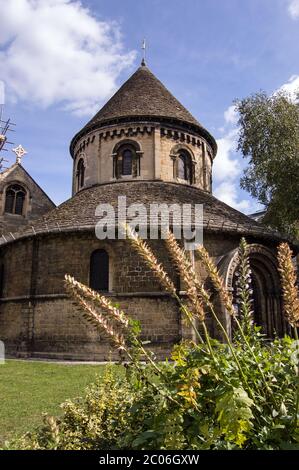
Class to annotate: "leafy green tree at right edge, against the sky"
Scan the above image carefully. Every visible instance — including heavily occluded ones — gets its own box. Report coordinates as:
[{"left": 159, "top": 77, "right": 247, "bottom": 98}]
[{"left": 235, "top": 91, "right": 299, "bottom": 234}]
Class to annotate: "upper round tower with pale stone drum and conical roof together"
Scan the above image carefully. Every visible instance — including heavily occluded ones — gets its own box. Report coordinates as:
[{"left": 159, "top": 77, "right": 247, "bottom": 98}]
[{"left": 70, "top": 65, "right": 217, "bottom": 194}]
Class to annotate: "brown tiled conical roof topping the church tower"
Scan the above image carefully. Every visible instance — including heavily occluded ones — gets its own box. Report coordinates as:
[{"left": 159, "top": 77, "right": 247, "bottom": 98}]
[{"left": 71, "top": 65, "right": 217, "bottom": 155}]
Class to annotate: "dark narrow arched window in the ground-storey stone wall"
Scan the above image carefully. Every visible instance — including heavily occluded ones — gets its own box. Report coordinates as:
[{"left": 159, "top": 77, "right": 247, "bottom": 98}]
[{"left": 89, "top": 250, "right": 109, "bottom": 292}]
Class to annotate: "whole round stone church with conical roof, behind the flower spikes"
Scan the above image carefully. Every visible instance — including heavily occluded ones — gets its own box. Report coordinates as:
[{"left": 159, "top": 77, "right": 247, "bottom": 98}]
[{"left": 0, "top": 62, "right": 296, "bottom": 360}]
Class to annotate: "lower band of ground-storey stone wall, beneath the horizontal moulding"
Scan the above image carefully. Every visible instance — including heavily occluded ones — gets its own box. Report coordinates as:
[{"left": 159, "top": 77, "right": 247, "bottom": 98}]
[{"left": 0, "top": 295, "right": 180, "bottom": 361}]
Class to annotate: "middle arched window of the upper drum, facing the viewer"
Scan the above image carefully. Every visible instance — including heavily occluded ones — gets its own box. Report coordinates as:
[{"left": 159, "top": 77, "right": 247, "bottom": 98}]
[{"left": 113, "top": 143, "right": 140, "bottom": 178}]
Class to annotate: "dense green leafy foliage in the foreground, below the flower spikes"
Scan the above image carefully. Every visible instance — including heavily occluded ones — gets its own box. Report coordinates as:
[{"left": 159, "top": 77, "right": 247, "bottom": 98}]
[{"left": 10, "top": 240, "right": 299, "bottom": 450}]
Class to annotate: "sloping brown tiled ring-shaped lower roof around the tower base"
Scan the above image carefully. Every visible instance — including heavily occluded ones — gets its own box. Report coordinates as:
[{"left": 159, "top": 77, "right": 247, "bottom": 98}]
[{"left": 0, "top": 181, "right": 296, "bottom": 250}]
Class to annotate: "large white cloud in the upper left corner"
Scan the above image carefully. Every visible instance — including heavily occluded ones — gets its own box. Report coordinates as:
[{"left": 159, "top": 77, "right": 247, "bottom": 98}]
[{"left": 0, "top": 0, "right": 135, "bottom": 115}]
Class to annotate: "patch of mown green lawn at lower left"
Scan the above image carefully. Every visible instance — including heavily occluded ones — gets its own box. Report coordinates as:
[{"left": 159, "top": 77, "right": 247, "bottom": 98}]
[{"left": 0, "top": 360, "right": 112, "bottom": 446}]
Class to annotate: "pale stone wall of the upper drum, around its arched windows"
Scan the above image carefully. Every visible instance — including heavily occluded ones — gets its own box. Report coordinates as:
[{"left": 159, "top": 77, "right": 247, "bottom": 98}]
[{"left": 73, "top": 123, "right": 212, "bottom": 194}]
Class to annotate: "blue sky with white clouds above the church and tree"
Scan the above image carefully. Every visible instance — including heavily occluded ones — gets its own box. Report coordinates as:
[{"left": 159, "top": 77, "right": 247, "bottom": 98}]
[{"left": 0, "top": 0, "right": 299, "bottom": 212}]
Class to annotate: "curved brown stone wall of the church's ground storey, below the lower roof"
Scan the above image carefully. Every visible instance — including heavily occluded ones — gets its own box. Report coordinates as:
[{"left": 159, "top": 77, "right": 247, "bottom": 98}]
[{"left": 0, "top": 224, "right": 282, "bottom": 360}]
